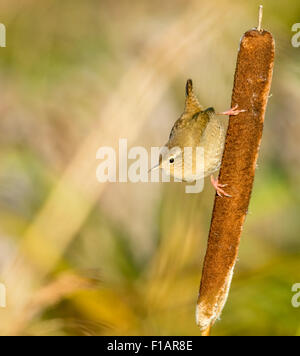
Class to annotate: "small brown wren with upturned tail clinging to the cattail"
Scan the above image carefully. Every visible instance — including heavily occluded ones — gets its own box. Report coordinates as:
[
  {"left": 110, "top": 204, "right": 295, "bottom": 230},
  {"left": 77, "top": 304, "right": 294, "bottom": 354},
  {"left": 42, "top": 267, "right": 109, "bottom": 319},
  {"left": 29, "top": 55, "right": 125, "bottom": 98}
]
[{"left": 153, "top": 79, "right": 245, "bottom": 196}]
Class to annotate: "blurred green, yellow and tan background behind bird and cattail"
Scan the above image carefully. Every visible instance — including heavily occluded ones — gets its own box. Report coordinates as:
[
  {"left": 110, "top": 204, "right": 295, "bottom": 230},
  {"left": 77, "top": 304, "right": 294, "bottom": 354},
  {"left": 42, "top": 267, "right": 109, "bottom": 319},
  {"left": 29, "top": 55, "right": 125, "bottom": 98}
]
[{"left": 0, "top": 0, "right": 300, "bottom": 335}]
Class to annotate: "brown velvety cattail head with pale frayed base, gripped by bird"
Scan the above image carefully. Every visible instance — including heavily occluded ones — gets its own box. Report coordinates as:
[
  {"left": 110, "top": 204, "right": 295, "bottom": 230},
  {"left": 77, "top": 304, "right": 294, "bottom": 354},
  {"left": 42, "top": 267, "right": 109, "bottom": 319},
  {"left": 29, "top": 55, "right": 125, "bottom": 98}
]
[{"left": 197, "top": 11, "right": 274, "bottom": 335}]
